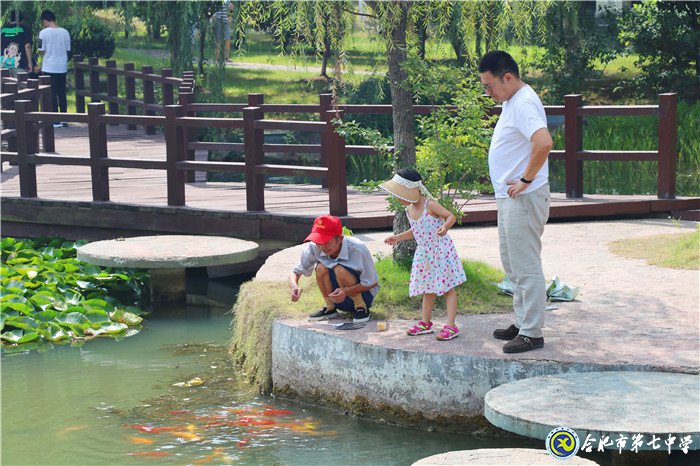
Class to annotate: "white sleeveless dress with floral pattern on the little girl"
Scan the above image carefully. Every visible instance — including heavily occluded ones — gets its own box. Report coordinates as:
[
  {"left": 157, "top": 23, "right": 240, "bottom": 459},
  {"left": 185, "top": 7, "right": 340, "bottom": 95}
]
[{"left": 407, "top": 201, "right": 467, "bottom": 296}]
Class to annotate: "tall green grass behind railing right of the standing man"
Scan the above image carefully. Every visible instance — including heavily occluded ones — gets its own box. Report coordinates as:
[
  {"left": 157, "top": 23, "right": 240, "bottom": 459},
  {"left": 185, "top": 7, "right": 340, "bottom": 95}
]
[{"left": 550, "top": 102, "right": 700, "bottom": 196}]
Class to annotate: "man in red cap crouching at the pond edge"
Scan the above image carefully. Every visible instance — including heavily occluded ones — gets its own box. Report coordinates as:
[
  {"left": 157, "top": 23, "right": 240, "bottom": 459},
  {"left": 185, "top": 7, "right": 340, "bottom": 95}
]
[{"left": 289, "top": 215, "right": 379, "bottom": 322}]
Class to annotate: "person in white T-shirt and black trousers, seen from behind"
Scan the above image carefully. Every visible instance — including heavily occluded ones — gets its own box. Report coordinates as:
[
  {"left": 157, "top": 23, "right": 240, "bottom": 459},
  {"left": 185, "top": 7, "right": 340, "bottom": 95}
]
[{"left": 39, "top": 10, "right": 70, "bottom": 127}]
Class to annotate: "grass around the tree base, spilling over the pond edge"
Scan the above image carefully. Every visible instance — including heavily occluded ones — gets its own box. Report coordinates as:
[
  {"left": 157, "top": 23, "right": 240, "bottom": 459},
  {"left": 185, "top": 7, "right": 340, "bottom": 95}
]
[{"left": 229, "top": 257, "right": 511, "bottom": 392}]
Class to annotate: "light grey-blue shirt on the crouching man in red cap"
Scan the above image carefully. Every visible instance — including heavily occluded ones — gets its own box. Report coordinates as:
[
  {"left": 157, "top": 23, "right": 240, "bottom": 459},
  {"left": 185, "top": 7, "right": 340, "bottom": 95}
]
[{"left": 293, "top": 236, "right": 379, "bottom": 296}]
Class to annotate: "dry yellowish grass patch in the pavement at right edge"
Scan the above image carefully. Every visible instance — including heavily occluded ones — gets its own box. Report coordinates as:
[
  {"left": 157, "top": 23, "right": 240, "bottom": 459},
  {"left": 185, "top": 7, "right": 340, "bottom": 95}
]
[{"left": 610, "top": 228, "right": 700, "bottom": 270}]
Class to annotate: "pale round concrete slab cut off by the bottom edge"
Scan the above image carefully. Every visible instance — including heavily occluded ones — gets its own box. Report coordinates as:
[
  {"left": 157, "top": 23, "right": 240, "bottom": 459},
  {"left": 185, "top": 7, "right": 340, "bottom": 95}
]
[{"left": 413, "top": 447, "right": 598, "bottom": 466}]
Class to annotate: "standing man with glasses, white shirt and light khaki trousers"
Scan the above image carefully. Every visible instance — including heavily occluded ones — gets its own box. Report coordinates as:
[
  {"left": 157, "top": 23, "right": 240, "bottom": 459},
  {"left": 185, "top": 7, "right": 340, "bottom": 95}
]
[{"left": 479, "top": 50, "right": 552, "bottom": 353}]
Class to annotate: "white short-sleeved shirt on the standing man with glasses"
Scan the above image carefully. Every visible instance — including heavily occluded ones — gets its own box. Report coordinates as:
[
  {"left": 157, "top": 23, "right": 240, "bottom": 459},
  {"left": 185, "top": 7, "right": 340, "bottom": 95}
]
[{"left": 489, "top": 84, "right": 549, "bottom": 198}]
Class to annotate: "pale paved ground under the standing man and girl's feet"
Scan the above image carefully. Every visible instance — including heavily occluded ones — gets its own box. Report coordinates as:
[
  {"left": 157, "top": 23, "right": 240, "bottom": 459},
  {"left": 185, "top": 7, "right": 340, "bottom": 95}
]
[{"left": 257, "top": 219, "right": 700, "bottom": 375}]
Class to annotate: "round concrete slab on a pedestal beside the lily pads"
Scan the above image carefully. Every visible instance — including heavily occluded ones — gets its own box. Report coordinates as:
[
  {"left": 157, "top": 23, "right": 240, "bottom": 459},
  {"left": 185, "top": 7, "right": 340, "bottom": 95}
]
[{"left": 77, "top": 235, "right": 258, "bottom": 302}]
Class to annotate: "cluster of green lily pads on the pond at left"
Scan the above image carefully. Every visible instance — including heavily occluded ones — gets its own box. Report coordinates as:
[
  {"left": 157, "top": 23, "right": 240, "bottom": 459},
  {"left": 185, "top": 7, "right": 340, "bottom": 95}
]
[{"left": 0, "top": 237, "right": 146, "bottom": 350}]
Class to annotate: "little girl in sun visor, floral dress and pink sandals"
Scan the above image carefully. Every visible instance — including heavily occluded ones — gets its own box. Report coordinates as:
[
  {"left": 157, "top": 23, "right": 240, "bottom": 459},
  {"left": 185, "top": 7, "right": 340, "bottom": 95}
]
[{"left": 381, "top": 169, "right": 467, "bottom": 340}]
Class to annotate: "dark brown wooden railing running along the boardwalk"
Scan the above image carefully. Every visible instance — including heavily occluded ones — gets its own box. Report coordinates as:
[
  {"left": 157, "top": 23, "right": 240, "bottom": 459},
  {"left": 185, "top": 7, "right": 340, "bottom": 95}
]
[{"left": 0, "top": 56, "right": 677, "bottom": 216}]
